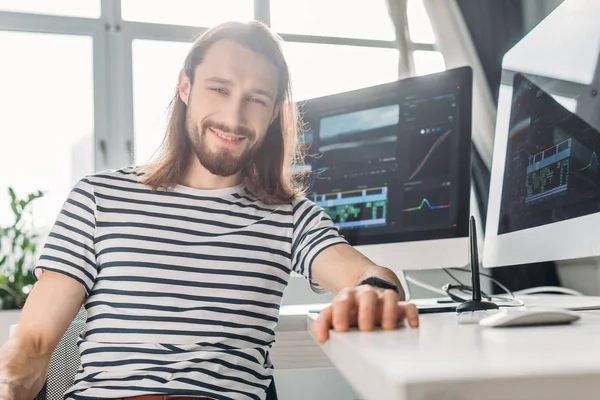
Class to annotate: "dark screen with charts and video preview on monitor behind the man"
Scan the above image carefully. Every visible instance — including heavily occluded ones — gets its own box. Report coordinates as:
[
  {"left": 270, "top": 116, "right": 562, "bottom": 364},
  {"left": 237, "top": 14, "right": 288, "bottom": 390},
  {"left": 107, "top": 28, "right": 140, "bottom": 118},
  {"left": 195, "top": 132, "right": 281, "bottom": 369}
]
[{"left": 304, "top": 67, "right": 470, "bottom": 242}]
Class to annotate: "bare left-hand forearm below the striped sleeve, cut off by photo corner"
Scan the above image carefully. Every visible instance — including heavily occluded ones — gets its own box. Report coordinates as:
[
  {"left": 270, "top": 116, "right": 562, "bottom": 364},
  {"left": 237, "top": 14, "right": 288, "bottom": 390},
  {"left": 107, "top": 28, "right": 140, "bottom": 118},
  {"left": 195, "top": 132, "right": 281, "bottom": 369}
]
[{"left": 0, "top": 271, "right": 85, "bottom": 400}]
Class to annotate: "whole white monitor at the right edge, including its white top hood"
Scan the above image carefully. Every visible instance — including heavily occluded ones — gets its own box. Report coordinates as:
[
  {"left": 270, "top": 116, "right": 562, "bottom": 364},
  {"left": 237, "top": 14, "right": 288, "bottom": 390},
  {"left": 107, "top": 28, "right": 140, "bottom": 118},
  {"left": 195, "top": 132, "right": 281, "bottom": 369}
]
[{"left": 483, "top": 0, "right": 600, "bottom": 267}]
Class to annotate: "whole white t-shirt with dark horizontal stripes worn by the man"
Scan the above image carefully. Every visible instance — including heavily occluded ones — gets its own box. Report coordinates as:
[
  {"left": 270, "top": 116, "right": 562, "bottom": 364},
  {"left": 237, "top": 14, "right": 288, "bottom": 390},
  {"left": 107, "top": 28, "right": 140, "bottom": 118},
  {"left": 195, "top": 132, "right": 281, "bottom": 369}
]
[{"left": 36, "top": 168, "right": 345, "bottom": 400}]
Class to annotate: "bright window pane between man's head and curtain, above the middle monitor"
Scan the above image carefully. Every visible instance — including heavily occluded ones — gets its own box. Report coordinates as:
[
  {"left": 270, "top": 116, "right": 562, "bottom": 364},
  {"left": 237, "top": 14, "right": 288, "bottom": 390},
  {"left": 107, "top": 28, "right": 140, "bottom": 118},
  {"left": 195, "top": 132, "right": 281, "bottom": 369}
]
[{"left": 283, "top": 42, "right": 399, "bottom": 101}]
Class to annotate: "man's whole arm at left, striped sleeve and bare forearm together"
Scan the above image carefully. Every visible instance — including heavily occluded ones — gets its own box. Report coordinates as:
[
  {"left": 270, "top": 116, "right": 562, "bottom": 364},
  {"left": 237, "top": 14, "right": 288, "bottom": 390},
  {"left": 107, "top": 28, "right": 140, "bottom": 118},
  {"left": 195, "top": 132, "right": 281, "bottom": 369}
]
[{"left": 0, "top": 178, "right": 98, "bottom": 400}]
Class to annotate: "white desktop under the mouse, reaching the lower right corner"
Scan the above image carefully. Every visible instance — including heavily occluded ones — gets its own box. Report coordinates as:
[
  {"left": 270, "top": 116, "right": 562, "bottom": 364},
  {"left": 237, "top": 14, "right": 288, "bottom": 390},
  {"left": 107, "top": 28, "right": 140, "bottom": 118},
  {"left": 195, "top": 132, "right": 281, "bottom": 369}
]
[{"left": 308, "top": 296, "right": 600, "bottom": 400}]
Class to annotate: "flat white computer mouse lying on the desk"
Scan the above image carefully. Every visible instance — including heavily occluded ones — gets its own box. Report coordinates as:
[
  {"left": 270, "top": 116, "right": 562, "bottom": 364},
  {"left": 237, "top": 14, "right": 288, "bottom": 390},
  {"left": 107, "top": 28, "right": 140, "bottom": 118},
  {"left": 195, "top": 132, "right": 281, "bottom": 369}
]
[{"left": 479, "top": 307, "right": 581, "bottom": 328}]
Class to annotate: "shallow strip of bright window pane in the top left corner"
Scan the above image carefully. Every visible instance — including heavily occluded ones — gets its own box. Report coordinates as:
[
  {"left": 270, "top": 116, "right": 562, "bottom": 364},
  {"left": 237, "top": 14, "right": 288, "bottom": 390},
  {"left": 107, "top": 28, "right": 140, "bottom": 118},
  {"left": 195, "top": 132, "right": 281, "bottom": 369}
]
[{"left": 0, "top": 0, "right": 100, "bottom": 18}]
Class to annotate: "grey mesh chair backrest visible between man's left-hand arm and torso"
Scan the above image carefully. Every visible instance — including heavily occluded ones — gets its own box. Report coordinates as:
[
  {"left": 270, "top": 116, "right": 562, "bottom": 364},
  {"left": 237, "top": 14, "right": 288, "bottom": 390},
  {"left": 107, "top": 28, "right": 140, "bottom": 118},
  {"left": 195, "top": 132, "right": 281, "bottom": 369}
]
[{"left": 35, "top": 307, "right": 86, "bottom": 400}]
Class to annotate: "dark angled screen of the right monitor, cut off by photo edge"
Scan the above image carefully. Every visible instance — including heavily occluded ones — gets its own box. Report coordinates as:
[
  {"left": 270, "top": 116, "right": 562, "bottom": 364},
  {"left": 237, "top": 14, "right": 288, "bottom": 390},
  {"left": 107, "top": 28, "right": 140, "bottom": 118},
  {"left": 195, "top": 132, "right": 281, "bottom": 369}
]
[{"left": 498, "top": 74, "right": 600, "bottom": 235}]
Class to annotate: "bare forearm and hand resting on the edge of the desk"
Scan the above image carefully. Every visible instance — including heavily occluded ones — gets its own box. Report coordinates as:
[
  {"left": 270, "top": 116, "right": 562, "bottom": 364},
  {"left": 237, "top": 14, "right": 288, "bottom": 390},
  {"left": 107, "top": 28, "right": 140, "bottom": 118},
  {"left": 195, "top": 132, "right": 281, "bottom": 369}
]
[{"left": 311, "top": 244, "right": 419, "bottom": 343}]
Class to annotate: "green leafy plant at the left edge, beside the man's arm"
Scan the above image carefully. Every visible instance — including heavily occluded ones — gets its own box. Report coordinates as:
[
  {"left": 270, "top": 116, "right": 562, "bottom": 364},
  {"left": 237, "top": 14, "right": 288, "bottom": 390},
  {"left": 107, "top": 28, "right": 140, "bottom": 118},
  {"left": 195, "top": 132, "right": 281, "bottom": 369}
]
[{"left": 0, "top": 187, "right": 44, "bottom": 309}]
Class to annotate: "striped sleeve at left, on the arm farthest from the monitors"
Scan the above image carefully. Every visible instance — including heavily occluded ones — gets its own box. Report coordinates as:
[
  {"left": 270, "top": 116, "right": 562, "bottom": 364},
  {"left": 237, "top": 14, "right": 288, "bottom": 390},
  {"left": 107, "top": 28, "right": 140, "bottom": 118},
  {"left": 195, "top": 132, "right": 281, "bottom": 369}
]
[{"left": 34, "top": 178, "right": 97, "bottom": 296}]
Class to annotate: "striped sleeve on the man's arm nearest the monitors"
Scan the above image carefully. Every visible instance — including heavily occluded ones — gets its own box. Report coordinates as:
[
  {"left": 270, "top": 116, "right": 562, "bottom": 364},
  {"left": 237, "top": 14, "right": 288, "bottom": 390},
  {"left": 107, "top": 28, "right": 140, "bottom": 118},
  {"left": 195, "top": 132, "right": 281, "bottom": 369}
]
[{"left": 292, "top": 198, "right": 348, "bottom": 293}]
